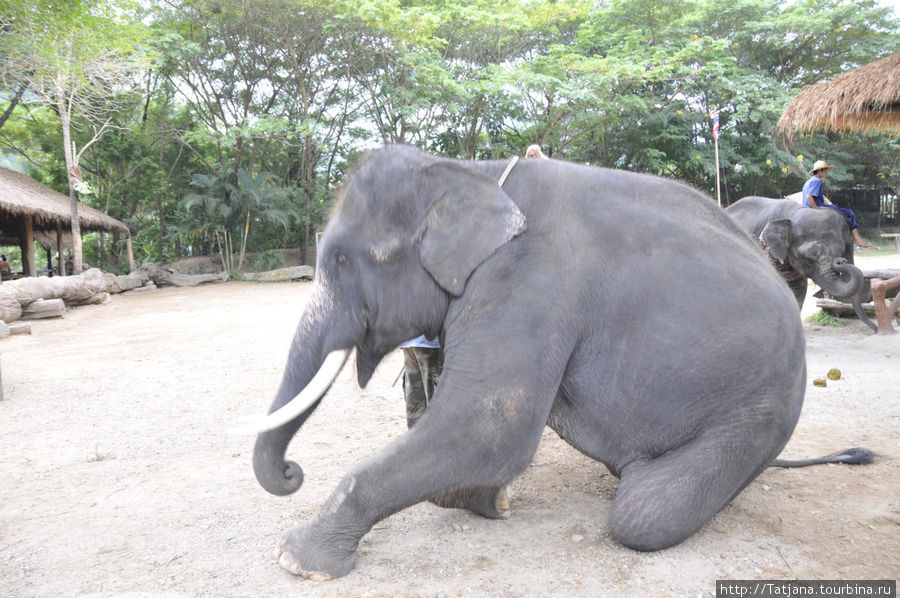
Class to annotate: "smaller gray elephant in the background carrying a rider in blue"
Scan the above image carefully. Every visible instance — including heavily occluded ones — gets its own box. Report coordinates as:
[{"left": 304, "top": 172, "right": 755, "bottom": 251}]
[{"left": 725, "top": 197, "right": 876, "bottom": 330}]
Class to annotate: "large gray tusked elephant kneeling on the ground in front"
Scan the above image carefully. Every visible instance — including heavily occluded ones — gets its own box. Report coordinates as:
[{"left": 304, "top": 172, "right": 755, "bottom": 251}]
[{"left": 239, "top": 146, "right": 806, "bottom": 579}]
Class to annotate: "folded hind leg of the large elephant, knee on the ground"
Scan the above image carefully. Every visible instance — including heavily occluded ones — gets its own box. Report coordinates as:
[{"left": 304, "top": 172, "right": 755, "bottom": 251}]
[{"left": 610, "top": 430, "right": 780, "bottom": 551}]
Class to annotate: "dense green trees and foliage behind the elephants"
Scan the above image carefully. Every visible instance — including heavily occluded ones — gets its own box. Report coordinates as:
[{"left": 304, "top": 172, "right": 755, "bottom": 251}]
[{"left": 0, "top": 0, "right": 900, "bottom": 268}]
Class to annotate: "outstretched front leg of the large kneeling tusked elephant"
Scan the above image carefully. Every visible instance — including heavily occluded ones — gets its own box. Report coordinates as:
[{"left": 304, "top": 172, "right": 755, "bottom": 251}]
[{"left": 277, "top": 376, "right": 549, "bottom": 579}]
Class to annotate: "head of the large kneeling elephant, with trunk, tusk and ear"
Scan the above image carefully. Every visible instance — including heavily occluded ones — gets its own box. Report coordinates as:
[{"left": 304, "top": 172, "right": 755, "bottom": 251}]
[{"left": 251, "top": 146, "right": 525, "bottom": 495}]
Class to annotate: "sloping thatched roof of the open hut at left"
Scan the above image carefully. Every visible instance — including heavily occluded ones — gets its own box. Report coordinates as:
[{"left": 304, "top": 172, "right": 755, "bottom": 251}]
[{"left": 0, "top": 168, "right": 128, "bottom": 234}]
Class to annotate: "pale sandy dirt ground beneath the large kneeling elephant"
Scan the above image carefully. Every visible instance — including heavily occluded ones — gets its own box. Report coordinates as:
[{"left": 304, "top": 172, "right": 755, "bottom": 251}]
[{"left": 0, "top": 255, "right": 900, "bottom": 598}]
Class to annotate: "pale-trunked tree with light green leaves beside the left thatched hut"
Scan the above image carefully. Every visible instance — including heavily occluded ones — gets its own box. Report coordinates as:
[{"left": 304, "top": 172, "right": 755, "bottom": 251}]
[{"left": 0, "top": 0, "right": 144, "bottom": 272}]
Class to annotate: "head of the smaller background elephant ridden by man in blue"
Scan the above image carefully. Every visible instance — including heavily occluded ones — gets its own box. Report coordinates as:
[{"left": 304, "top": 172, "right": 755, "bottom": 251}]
[{"left": 760, "top": 208, "right": 863, "bottom": 303}]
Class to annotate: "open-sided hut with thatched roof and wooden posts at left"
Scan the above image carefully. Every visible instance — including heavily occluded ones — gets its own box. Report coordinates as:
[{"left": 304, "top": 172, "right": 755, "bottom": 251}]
[{"left": 0, "top": 168, "right": 134, "bottom": 276}]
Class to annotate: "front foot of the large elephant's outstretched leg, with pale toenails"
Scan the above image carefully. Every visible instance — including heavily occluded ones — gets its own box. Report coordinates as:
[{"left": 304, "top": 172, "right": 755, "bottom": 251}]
[{"left": 275, "top": 523, "right": 358, "bottom": 581}]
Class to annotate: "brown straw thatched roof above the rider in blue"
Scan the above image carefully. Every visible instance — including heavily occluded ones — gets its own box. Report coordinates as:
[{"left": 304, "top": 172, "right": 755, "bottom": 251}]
[{"left": 776, "top": 52, "right": 900, "bottom": 135}]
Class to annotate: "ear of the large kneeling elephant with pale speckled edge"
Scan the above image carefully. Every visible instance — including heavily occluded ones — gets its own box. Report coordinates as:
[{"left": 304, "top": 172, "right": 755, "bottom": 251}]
[{"left": 418, "top": 163, "right": 525, "bottom": 296}]
